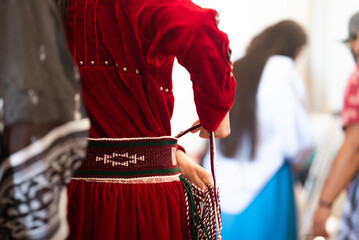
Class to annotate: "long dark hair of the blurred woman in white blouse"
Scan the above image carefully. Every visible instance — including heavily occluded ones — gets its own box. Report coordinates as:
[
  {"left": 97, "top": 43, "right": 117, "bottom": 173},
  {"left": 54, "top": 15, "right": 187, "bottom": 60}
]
[{"left": 219, "top": 20, "right": 307, "bottom": 159}]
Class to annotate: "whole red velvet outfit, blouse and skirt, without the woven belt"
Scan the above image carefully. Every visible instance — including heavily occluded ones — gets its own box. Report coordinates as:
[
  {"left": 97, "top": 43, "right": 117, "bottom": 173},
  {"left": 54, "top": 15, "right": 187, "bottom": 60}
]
[{"left": 66, "top": 0, "right": 236, "bottom": 240}]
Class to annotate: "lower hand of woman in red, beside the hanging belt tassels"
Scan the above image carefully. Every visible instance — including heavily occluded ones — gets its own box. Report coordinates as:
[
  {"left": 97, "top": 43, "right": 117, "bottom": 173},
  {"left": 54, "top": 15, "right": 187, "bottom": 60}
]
[{"left": 176, "top": 150, "right": 213, "bottom": 190}]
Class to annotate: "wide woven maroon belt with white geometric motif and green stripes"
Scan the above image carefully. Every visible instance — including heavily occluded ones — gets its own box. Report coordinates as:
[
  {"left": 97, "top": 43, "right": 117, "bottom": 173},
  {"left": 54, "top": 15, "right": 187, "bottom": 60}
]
[{"left": 72, "top": 137, "right": 179, "bottom": 183}]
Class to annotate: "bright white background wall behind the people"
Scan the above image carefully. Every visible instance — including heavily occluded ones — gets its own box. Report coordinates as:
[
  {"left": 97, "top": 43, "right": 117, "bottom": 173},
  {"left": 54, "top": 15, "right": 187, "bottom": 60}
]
[{"left": 172, "top": 0, "right": 359, "bottom": 157}]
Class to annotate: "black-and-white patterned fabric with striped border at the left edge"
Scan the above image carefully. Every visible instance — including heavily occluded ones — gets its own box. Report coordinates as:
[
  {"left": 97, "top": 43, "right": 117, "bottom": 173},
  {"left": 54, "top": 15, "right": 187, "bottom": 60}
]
[{"left": 0, "top": 119, "right": 90, "bottom": 239}]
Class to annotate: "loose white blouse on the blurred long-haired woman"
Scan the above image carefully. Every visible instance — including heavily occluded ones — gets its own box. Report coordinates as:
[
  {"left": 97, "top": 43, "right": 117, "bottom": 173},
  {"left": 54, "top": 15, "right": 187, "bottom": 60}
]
[{"left": 204, "top": 56, "right": 313, "bottom": 214}]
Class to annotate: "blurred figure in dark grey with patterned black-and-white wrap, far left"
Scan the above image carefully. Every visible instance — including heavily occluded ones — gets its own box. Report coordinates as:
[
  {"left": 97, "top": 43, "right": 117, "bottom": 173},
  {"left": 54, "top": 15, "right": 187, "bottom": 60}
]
[{"left": 0, "top": 0, "right": 89, "bottom": 239}]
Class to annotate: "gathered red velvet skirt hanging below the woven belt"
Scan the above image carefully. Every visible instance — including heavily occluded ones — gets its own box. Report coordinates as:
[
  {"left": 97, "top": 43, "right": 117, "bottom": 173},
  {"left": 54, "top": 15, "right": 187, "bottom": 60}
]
[{"left": 68, "top": 181, "right": 189, "bottom": 240}]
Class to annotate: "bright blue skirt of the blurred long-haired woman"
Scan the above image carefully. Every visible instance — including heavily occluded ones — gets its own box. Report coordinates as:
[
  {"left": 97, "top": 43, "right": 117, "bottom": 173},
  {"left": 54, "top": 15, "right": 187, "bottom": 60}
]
[{"left": 222, "top": 162, "right": 297, "bottom": 240}]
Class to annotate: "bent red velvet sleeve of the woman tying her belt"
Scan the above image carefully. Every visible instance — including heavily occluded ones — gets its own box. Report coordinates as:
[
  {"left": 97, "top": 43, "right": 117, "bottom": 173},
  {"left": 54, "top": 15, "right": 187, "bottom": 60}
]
[{"left": 135, "top": 0, "right": 236, "bottom": 131}]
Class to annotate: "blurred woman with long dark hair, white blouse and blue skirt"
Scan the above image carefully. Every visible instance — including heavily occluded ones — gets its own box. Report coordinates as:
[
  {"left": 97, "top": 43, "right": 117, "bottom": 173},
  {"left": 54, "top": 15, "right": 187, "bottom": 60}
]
[{"left": 205, "top": 20, "right": 313, "bottom": 240}]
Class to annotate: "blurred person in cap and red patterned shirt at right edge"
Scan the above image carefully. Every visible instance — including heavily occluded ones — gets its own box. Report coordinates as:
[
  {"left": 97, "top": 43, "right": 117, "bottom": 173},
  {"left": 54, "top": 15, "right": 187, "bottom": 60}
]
[{"left": 313, "top": 13, "right": 359, "bottom": 240}]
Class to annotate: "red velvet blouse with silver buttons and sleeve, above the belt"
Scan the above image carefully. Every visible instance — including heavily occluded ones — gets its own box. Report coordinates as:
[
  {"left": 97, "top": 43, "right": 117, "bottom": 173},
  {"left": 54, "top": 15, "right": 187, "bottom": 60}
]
[{"left": 66, "top": 0, "right": 235, "bottom": 138}]
